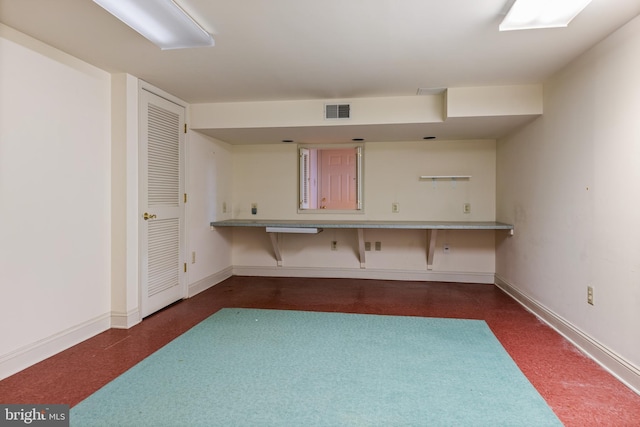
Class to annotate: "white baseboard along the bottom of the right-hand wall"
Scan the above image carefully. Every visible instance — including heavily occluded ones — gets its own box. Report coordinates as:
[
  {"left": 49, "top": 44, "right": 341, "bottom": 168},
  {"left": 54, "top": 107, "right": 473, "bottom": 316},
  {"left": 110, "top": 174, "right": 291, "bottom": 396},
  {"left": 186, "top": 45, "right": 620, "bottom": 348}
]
[{"left": 495, "top": 275, "right": 640, "bottom": 394}]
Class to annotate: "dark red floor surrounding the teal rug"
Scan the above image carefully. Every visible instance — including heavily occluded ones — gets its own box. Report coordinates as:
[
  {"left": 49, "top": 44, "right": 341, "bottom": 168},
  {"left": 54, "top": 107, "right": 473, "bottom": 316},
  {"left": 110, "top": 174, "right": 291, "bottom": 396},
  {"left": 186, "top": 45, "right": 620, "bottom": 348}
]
[{"left": 0, "top": 277, "right": 640, "bottom": 427}]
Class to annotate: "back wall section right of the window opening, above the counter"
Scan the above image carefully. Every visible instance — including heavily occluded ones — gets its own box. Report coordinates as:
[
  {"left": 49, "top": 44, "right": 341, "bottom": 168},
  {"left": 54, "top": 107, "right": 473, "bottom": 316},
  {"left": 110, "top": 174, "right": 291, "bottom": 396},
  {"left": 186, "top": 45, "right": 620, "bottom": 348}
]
[{"left": 364, "top": 140, "right": 496, "bottom": 221}]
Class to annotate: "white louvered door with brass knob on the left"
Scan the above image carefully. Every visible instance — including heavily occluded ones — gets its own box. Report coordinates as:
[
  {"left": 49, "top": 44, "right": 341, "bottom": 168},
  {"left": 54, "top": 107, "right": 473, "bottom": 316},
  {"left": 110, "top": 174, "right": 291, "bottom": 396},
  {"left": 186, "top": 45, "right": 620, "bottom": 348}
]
[{"left": 140, "top": 90, "right": 184, "bottom": 316}]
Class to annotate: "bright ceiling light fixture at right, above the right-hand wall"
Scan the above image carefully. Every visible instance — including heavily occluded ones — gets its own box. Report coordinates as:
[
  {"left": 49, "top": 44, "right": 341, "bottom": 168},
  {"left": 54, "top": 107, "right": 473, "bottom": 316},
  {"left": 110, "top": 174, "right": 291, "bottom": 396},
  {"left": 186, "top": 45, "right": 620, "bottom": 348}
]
[{"left": 499, "top": 0, "right": 591, "bottom": 31}]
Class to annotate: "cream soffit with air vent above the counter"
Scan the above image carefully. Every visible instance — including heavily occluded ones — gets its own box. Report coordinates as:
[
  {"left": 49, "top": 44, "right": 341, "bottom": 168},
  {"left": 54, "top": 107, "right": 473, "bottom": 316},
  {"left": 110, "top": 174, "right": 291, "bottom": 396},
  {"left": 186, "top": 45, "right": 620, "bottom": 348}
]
[{"left": 189, "top": 85, "right": 542, "bottom": 145}]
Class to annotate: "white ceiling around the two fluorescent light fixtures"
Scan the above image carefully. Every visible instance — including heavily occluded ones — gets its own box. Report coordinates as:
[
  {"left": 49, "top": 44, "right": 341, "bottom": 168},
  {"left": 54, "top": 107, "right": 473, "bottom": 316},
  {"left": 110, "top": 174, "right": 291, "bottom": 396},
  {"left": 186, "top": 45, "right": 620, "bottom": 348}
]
[{"left": 0, "top": 0, "right": 640, "bottom": 142}]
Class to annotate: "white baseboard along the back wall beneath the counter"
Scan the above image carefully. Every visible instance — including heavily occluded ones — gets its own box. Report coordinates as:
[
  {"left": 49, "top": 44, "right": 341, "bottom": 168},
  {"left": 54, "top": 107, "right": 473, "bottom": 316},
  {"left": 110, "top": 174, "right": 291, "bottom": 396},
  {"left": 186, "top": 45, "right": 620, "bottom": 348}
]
[{"left": 233, "top": 266, "right": 495, "bottom": 284}]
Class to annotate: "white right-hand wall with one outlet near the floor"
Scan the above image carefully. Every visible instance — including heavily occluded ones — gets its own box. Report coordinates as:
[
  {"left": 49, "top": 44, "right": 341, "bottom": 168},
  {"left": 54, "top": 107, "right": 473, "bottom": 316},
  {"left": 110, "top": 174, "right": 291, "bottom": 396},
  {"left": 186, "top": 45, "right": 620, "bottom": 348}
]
[{"left": 496, "top": 18, "right": 640, "bottom": 390}]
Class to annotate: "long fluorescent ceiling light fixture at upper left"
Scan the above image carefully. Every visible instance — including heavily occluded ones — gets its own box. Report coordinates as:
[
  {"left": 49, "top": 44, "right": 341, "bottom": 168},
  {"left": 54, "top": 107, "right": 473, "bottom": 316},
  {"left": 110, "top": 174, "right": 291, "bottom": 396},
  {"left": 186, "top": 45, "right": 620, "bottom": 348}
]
[{"left": 93, "top": 0, "right": 214, "bottom": 50}]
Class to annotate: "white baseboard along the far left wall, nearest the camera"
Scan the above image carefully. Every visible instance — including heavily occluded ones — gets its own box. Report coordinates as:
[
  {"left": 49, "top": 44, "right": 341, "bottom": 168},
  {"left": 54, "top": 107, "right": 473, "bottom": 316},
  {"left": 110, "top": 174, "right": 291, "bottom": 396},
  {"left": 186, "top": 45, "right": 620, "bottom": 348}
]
[{"left": 0, "top": 313, "right": 111, "bottom": 380}]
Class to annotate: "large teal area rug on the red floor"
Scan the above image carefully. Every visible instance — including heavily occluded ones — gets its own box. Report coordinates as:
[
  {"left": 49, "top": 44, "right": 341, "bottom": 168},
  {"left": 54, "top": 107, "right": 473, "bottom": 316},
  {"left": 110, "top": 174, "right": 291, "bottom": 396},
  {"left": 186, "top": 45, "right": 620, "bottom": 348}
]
[{"left": 70, "top": 308, "right": 562, "bottom": 427}]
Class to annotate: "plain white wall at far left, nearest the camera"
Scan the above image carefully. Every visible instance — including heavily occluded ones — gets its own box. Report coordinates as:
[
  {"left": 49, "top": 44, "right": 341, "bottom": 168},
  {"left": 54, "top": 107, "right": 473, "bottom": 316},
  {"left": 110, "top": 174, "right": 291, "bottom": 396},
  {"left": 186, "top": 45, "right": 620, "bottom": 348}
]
[{"left": 0, "top": 24, "right": 111, "bottom": 378}]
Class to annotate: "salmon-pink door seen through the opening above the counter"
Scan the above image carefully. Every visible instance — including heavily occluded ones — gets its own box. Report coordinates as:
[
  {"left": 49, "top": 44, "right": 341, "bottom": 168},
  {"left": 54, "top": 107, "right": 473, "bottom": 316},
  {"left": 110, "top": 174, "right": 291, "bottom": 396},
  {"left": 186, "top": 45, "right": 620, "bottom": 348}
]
[{"left": 319, "top": 148, "right": 358, "bottom": 209}]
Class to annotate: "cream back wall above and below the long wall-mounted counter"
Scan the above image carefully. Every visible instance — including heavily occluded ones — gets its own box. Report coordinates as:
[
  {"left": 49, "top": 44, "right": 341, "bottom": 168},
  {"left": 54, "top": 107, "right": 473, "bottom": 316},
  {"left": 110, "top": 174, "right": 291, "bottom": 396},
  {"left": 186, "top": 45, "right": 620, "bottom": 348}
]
[{"left": 228, "top": 140, "right": 495, "bottom": 283}]
